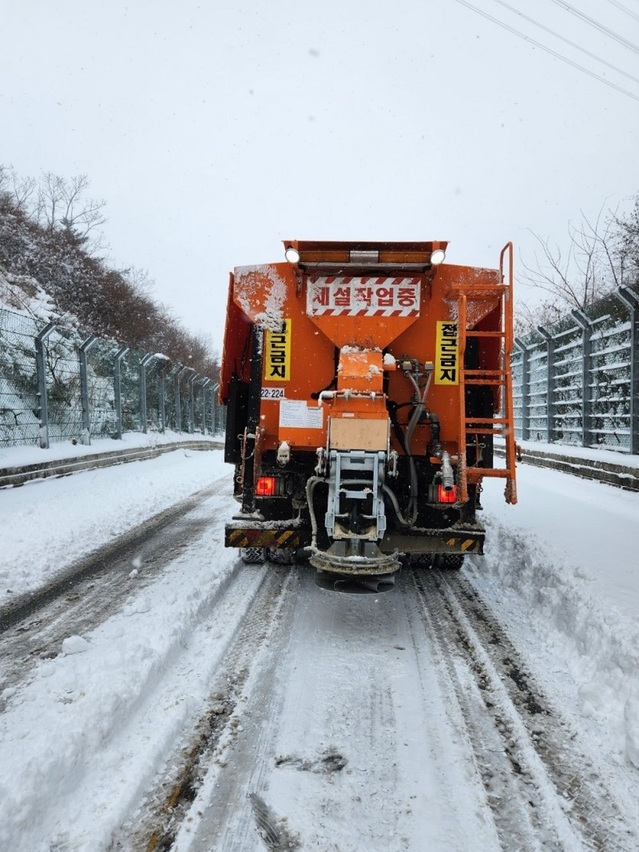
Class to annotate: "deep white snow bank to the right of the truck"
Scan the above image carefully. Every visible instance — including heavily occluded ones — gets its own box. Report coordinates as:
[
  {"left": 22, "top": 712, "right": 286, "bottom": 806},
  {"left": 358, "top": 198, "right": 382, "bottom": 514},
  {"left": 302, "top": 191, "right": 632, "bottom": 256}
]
[{"left": 478, "top": 466, "right": 639, "bottom": 768}]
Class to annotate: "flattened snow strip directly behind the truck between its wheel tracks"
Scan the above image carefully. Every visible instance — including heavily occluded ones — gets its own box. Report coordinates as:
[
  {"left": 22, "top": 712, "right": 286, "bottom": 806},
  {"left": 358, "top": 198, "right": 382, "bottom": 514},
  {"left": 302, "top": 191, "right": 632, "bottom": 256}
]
[{"left": 178, "top": 567, "right": 496, "bottom": 852}]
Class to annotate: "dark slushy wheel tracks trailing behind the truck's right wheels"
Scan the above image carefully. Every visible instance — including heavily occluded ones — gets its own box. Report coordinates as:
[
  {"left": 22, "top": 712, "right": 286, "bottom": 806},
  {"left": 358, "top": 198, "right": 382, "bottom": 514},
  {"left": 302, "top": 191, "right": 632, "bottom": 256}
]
[{"left": 413, "top": 571, "right": 638, "bottom": 852}]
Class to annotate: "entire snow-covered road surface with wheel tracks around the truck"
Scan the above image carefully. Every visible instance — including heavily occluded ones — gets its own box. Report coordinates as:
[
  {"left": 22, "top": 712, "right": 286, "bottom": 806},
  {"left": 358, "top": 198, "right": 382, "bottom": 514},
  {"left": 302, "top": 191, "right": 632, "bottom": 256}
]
[{"left": 0, "top": 451, "right": 639, "bottom": 852}]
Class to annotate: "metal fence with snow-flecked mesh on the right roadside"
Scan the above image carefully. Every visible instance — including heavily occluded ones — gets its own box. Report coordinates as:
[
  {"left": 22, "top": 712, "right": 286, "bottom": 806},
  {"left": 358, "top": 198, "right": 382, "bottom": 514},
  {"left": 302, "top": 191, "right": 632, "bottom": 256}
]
[{"left": 511, "top": 287, "right": 639, "bottom": 454}]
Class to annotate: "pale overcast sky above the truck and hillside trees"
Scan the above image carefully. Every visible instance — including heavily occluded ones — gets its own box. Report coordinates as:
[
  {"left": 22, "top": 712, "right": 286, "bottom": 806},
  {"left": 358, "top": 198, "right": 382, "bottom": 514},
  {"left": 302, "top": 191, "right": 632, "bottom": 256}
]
[{"left": 0, "top": 0, "right": 639, "bottom": 348}]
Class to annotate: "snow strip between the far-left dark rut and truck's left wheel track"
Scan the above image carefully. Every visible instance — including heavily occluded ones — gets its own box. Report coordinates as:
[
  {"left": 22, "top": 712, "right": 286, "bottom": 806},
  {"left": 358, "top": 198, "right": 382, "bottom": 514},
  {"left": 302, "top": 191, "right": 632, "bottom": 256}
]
[{"left": 0, "top": 486, "right": 265, "bottom": 852}]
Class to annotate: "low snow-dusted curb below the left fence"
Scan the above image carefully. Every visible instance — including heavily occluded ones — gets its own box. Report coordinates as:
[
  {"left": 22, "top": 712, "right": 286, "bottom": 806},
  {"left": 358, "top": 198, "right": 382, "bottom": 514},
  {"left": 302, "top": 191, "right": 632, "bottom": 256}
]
[{"left": 0, "top": 440, "right": 224, "bottom": 488}]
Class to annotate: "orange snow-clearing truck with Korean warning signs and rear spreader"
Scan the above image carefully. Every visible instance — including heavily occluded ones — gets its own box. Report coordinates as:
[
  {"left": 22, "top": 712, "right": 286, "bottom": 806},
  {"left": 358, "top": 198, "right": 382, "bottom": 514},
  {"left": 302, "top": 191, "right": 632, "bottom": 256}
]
[{"left": 219, "top": 240, "right": 516, "bottom": 585}]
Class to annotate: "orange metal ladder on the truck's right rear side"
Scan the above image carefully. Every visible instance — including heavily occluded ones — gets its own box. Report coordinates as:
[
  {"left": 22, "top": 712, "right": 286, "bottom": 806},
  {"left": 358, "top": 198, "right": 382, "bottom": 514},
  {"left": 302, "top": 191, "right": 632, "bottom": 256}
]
[{"left": 451, "top": 243, "right": 517, "bottom": 503}]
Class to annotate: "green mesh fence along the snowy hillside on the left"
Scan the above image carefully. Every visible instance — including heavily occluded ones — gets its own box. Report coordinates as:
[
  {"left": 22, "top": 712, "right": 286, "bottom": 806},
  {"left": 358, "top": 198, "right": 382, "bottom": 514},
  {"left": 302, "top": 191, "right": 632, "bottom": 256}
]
[{"left": 0, "top": 310, "right": 224, "bottom": 447}]
